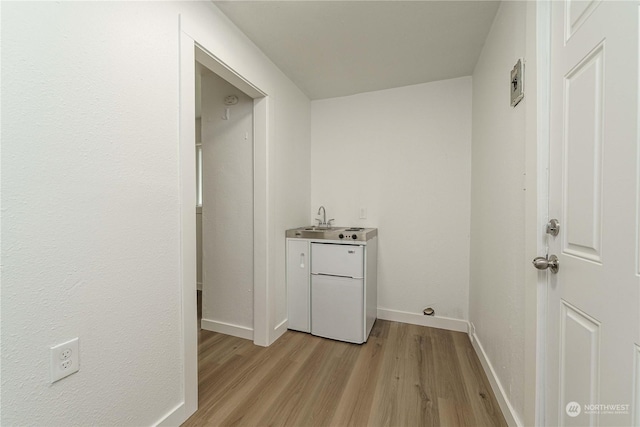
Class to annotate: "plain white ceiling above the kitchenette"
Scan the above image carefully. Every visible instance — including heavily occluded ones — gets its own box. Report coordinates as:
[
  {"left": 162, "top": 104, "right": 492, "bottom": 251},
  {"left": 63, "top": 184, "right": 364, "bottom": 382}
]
[{"left": 214, "top": 0, "right": 499, "bottom": 99}]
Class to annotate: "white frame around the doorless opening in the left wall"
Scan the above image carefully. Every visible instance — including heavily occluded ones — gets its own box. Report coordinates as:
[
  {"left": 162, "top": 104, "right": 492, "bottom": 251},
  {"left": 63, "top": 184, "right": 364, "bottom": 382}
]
[{"left": 172, "top": 15, "right": 273, "bottom": 425}]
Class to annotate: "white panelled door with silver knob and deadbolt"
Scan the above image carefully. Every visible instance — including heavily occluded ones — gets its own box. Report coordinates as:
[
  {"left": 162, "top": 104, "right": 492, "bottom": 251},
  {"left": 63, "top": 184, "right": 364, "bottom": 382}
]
[{"left": 545, "top": 0, "right": 640, "bottom": 426}]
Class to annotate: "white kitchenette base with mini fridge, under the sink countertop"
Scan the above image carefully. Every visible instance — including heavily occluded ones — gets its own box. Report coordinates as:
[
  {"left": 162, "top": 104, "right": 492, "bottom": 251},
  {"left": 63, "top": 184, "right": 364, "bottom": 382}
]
[{"left": 286, "top": 236, "right": 378, "bottom": 343}]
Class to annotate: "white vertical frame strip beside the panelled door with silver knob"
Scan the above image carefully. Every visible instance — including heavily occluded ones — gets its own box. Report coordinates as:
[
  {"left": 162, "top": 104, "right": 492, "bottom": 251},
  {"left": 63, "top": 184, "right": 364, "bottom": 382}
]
[{"left": 524, "top": 1, "right": 551, "bottom": 425}]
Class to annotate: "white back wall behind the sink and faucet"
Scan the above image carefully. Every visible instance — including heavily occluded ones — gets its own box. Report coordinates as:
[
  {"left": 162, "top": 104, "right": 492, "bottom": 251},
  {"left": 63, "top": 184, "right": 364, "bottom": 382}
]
[{"left": 312, "top": 77, "right": 471, "bottom": 319}]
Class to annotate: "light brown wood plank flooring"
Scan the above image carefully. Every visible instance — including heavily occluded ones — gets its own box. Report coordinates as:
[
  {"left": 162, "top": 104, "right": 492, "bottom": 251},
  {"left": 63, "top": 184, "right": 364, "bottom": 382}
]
[{"left": 183, "top": 320, "right": 507, "bottom": 426}]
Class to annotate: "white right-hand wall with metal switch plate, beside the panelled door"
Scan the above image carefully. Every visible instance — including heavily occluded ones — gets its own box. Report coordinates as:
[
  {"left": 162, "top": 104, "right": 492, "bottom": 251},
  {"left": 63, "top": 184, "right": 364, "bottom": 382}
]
[{"left": 469, "top": 2, "right": 536, "bottom": 423}]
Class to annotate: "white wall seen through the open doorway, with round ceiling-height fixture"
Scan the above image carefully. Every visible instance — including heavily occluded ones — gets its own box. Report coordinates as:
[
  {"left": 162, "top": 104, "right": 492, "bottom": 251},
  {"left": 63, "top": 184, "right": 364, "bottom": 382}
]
[{"left": 202, "top": 73, "right": 253, "bottom": 332}]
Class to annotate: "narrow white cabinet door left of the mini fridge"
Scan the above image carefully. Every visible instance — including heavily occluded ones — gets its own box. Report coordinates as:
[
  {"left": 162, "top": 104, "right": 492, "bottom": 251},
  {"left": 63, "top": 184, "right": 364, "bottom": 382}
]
[{"left": 287, "top": 239, "right": 311, "bottom": 332}]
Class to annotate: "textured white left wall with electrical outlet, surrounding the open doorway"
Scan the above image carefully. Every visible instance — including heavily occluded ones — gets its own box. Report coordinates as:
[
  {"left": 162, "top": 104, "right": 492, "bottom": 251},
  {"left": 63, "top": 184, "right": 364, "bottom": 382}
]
[{"left": 0, "top": 2, "right": 310, "bottom": 426}]
